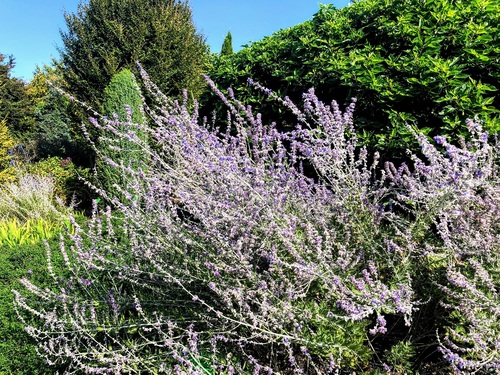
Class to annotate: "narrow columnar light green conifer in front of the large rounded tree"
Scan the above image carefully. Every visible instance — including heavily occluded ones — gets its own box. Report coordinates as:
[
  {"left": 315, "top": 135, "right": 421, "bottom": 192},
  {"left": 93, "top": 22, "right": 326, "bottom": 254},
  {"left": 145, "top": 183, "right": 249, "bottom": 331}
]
[{"left": 97, "top": 69, "right": 147, "bottom": 201}]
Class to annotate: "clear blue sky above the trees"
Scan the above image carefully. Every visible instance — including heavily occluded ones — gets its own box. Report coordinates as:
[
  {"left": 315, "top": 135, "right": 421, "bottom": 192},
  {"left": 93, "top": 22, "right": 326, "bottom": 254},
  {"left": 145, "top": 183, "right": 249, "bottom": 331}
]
[{"left": 0, "top": 0, "right": 348, "bottom": 80}]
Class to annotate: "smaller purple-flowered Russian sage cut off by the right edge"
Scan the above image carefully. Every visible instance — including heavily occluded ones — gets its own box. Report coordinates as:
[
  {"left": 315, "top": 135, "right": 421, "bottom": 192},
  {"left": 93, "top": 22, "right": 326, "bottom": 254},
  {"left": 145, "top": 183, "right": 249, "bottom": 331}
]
[{"left": 387, "top": 124, "right": 500, "bottom": 373}]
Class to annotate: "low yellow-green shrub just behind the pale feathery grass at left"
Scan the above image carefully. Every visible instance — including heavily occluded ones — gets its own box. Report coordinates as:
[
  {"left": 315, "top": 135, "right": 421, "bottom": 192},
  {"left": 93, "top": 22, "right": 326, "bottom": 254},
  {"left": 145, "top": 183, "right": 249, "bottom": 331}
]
[{"left": 25, "top": 157, "right": 92, "bottom": 204}]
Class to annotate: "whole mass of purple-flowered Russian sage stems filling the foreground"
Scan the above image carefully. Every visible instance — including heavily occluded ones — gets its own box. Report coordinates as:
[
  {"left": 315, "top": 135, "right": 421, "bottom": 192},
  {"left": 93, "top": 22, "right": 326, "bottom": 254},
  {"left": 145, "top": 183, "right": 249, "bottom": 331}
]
[{"left": 16, "top": 71, "right": 500, "bottom": 374}]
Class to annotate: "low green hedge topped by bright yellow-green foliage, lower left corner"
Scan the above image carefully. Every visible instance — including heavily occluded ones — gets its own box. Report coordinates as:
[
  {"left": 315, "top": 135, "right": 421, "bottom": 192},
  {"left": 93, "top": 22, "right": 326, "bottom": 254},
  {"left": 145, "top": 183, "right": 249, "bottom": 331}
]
[{"left": 0, "top": 213, "right": 87, "bottom": 375}]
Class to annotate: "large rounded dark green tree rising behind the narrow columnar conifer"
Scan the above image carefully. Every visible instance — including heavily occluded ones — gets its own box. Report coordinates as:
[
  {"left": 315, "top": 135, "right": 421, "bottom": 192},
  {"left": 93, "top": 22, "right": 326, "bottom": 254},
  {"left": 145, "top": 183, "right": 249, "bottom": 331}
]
[{"left": 61, "top": 0, "right": 208, "bottom": 108}]
